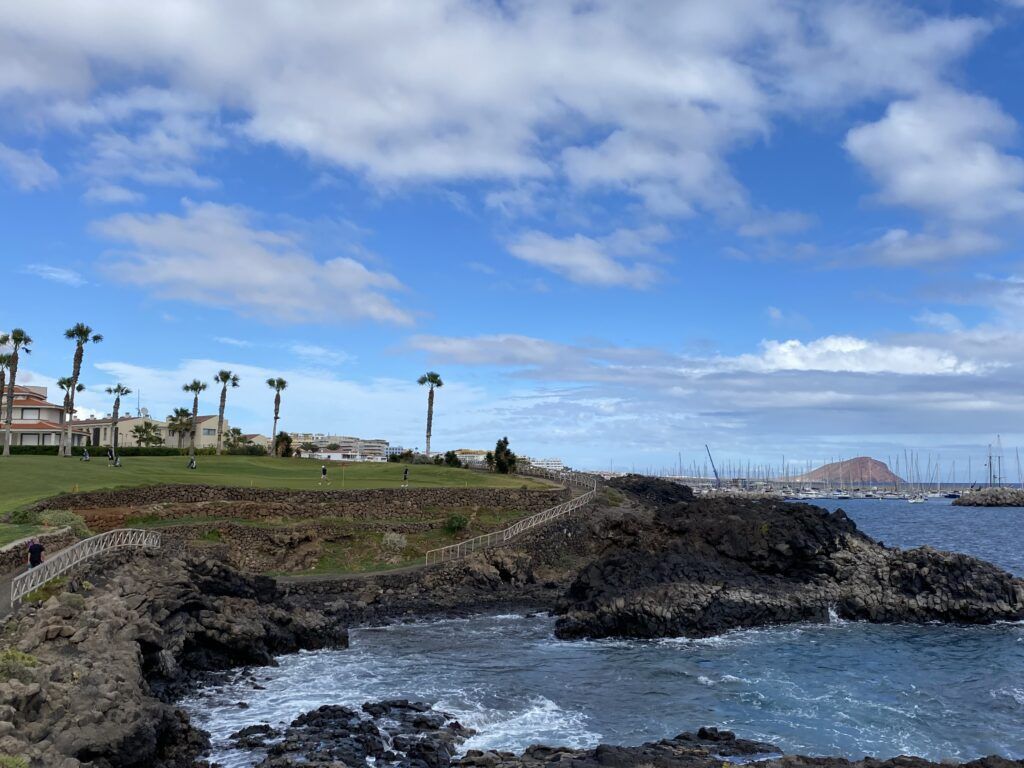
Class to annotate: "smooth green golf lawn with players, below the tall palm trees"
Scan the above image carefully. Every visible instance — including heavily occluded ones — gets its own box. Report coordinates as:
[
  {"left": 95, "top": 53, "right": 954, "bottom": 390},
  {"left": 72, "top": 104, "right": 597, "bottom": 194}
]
[{"left": 0, "top": 456, "right": 546, "bottom": 515}]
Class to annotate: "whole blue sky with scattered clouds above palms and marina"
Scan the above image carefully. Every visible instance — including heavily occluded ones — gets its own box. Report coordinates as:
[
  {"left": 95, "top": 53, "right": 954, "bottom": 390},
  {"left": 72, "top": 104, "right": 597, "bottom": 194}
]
[{"left": 0, "top": 0, "right": 1024, "bottom": 479}]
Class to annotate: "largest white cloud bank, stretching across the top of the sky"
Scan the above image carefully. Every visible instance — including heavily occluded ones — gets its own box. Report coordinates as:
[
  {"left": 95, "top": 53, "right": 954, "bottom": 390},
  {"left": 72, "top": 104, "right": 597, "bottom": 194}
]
[{"left": 0, "top": 0, "right": 988, "bottom": 221}]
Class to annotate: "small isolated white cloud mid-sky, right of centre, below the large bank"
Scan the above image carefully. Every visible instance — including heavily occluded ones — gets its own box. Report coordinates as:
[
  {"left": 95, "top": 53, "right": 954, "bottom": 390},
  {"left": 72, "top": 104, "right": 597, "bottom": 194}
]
[{"left": 508, "top": 227, "right": 668, "bottom": 289}]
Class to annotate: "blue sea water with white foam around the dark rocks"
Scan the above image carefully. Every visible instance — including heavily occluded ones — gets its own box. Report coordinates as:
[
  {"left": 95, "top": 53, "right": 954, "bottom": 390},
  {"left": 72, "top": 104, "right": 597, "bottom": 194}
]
[{"left": 185, "top": 500, "right": 1024, "bottom": 768}]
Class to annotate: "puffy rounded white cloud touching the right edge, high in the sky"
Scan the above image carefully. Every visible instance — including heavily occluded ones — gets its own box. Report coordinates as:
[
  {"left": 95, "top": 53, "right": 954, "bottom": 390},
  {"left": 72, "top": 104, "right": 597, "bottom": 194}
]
[{"left": 846, "top": 89, "right": 1024, "bottom": 221}]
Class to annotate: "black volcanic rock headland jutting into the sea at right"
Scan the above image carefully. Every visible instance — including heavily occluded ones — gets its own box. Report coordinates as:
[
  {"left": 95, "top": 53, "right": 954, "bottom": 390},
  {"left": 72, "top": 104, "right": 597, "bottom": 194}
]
[{"left": 556, "top": 478, "right": 1024, "bottom": 638}]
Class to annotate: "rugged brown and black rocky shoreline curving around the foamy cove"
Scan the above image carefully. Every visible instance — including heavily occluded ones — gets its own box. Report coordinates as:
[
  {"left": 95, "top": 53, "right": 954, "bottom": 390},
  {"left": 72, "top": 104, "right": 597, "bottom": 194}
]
[{"left": 0, "top": 478, "right": 1024, "bottom": 768}]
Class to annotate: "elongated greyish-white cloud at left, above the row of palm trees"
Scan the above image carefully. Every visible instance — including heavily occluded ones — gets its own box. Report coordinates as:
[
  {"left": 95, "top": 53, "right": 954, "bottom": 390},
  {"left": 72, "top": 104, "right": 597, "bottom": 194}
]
[{"left": 94, "top": 201, "right": 412, "bottom": 325}]
